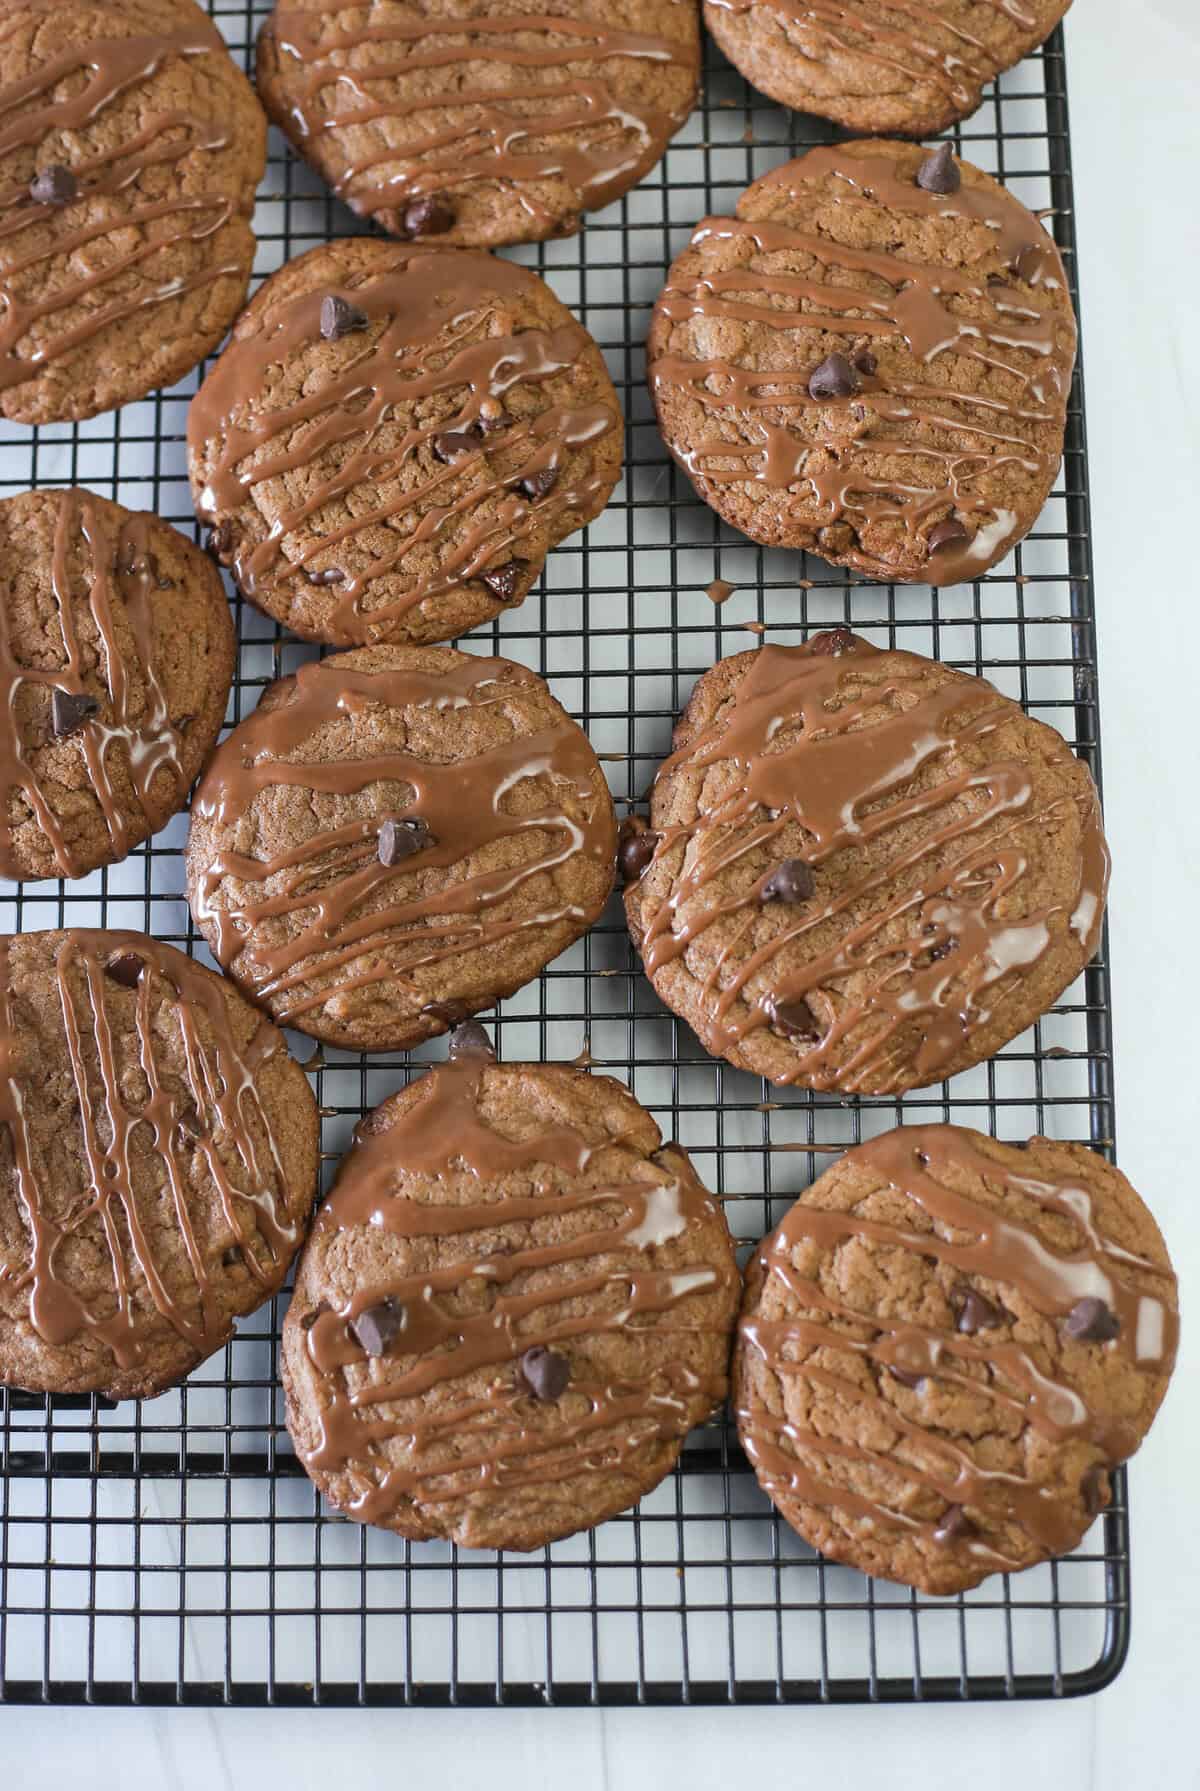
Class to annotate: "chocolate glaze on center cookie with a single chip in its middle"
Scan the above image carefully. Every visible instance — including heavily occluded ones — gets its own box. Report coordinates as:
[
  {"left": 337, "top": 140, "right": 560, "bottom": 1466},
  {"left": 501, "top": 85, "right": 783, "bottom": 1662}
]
[{"left": 195, "top": 657, "right": 611, "bottom": 1019}]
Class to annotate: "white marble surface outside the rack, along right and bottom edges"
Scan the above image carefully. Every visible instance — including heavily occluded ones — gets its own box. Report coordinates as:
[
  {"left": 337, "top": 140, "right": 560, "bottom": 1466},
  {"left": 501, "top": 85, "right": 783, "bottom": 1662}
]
[{"left": 9, "top": 0, "right": 1200, "bottom": 1769}]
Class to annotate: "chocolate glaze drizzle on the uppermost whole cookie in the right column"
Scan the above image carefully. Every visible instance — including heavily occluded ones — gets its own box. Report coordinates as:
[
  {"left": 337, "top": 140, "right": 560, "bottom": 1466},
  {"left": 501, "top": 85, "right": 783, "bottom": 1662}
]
[{"left": 650, "top": 147, "right": 1075, "bottom": 584}]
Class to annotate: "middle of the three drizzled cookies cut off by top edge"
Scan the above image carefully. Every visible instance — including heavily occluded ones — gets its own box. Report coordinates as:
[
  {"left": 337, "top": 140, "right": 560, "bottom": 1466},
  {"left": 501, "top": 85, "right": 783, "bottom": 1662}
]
[{"left": 258, "top": 0, "right": 700, "bottom": 249}]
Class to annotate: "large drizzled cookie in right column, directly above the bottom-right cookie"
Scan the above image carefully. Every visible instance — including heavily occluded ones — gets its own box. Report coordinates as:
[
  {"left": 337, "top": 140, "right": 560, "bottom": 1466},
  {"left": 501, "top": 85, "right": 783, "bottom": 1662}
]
[{"left": 621, "top": 629, "right": 1109, "bottom": 1094}]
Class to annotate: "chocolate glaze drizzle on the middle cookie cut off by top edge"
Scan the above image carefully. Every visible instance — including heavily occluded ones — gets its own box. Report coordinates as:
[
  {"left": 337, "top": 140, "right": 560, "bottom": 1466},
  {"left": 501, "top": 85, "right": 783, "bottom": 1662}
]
[{"left": 272, "top": 4, "right": 699, "bottom": 224}]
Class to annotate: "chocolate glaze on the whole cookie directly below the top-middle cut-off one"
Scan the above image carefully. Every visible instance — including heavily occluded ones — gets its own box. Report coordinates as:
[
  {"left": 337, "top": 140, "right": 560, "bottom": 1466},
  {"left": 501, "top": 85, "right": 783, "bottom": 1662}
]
[{"left": 188, "top": 249, "right": 620, "bottom": 645}]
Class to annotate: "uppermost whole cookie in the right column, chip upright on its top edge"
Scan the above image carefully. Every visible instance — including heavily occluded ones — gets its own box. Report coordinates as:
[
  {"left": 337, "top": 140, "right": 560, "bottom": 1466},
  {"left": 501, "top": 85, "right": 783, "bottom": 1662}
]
[{"left": 648, "top": 141, "right": 1076, "bottom": 584}]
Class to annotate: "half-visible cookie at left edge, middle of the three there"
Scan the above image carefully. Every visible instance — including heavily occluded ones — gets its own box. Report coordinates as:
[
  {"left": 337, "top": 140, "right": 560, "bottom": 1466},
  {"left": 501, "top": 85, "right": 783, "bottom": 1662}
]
[{"left": 0, "top": 491, "right": 235, "bottom": 878}]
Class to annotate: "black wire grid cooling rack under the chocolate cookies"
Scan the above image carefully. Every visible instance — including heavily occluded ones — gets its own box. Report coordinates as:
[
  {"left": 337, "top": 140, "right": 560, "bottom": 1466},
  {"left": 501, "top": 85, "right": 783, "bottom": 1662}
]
[{"left": 0, "top": 0, "right": 1128, "bottom": 1705}]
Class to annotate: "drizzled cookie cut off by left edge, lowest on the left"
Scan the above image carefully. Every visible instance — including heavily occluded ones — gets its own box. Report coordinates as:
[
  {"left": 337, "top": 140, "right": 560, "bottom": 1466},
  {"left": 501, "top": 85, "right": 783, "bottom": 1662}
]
[{"left": 0, "top": 928, "right": 317, "bottom": 1399}]
